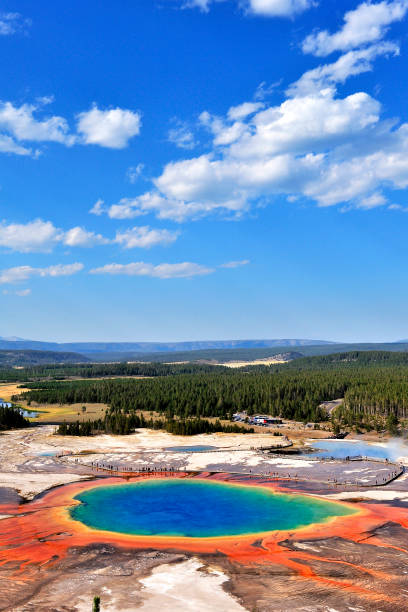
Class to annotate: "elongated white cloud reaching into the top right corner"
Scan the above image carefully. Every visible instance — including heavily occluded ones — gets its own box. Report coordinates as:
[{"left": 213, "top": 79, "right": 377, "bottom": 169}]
[{"left": 302, "top": 0, "right": 408, "bottom": 57}]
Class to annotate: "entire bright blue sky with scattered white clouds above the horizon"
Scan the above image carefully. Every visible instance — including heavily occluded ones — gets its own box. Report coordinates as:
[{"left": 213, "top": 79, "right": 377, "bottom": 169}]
[{"left": 0, "top": 0, "right": 408, "bottom": 341}]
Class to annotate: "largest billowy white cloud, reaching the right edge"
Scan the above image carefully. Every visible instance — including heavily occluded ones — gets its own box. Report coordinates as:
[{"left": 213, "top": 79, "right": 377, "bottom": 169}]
[{"left": 122, "top": 89, "right": 408, "bottom": 216}]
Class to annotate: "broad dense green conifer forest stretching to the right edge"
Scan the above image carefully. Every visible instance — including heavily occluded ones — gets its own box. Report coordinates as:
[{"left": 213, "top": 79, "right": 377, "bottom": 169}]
[{"left": 13, "top": 358, "right": 408, "bottom": 422}]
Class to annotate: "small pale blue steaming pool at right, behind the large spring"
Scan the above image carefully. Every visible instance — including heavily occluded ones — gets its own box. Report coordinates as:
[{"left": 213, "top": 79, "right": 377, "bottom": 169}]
[{"left": 309, "top": 440, "right": 399, "bottom": 460}]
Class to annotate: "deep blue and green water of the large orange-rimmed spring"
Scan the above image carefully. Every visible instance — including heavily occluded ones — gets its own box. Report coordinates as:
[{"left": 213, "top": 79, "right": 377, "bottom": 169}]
[{"left": 71, "top": 479, "right": 353, "bottom": 537}]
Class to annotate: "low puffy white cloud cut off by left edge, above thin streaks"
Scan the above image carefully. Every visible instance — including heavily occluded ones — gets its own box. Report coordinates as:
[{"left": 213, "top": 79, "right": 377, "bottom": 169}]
[{"left": 0, "top": 219, "right": 63, "bottom": 253}]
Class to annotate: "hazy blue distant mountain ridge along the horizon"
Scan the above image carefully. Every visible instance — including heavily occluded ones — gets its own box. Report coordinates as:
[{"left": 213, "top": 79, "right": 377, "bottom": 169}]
[{"left": 0, "top": 336, "right": 333, "bottom": 355}]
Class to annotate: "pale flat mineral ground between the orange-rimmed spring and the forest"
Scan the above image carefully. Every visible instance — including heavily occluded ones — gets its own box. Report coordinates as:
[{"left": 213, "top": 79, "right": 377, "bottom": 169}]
[{"left": 0, "top": 425, "right": 408, "bottom": 498}]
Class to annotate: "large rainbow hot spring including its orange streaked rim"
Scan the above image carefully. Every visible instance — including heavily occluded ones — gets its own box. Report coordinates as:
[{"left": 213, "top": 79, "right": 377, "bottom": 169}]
[{"left": 0, "top": 472, "right": 408, "bottom": 610}]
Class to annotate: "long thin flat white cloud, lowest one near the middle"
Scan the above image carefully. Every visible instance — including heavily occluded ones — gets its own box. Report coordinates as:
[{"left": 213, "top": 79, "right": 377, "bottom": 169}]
[{"left": 91, "top": 261, "right": 214, "bottom": 278}]
